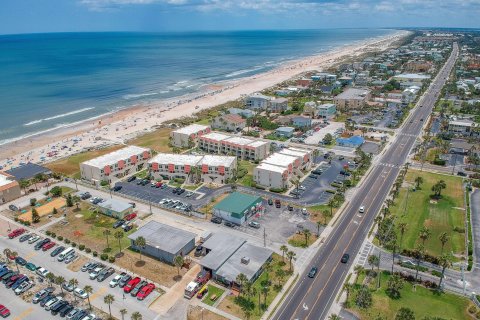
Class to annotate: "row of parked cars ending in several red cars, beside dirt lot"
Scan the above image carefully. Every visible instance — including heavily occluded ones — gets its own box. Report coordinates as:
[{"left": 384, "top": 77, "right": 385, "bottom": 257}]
[{"left": 80, "top": 261, "right": 155, "bottom": 300}]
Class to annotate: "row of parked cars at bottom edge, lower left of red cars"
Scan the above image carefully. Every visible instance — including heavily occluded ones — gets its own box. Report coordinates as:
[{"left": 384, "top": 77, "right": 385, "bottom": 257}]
[{"left": 32, "top": 287, "right": 97, "bottom": 320}]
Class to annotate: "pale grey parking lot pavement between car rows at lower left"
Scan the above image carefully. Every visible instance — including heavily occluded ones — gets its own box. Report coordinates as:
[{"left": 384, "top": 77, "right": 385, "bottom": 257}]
[{"left": 0, "top": 220, "right": 159, "bottom": 320}]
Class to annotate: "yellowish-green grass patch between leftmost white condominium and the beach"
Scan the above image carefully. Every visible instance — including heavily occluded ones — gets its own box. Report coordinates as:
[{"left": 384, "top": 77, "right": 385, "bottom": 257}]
[{"left": 45, "top": 145, "right": 124, "bottom": 179}]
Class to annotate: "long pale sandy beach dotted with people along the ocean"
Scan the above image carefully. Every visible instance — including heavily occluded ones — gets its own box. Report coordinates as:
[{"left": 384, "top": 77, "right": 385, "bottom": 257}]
[{"left": 0, "top": 31, "right": 409, "bottom": 170}]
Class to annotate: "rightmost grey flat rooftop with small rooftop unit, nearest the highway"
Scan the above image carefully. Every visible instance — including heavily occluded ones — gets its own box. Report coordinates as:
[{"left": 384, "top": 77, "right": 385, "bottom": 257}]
[{"left": 217, "top": 242, "right": 273, "bottom": 281}]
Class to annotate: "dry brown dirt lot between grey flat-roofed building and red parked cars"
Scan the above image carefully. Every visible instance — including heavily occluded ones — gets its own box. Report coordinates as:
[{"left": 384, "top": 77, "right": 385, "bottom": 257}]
[{"left": 115, "top": 250, "right": 193, "bottom": 287}]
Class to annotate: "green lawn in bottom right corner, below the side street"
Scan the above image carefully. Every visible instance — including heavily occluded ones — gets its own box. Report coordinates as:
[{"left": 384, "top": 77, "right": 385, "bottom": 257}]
[{"left": 349, "top": 273, "right": 471, "bottom": 320}]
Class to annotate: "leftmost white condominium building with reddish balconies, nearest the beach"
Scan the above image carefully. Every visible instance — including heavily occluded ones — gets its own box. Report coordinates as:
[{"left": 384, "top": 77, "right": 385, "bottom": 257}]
[{"left": 80, "top": 146, "right": 152, "bottom": 184}]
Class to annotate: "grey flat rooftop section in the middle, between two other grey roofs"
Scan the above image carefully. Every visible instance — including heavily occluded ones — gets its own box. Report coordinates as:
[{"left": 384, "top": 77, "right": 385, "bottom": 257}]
[{"left": 200, "top": 233, "right": 246, "bottom": 270}]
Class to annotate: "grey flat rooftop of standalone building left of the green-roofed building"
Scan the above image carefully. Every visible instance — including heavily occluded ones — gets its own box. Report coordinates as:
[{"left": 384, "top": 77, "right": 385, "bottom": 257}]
[{"left": 128, "top": 221, "right": 196, "bottom": 254}]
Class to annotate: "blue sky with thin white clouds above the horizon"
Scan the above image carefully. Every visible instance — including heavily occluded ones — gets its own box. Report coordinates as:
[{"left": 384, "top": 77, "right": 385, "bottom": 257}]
[{"left": 0, "top": 0, "right": 480, "bottom": 34}]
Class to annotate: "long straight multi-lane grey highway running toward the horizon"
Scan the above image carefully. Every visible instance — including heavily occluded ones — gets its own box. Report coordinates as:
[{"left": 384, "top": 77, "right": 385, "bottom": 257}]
[{"left": 273, "top": 43, "right": 458, "bottom": 320}]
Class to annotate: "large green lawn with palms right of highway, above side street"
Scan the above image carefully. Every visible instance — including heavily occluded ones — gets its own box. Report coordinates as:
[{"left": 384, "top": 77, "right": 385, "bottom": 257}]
[{"left": 391, "top": 170, "right": 465, "bottom": 256}]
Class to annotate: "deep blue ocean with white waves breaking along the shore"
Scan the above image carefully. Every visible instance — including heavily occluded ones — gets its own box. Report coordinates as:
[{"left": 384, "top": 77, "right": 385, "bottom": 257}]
[{"left": 0, "top": 29, "right": 394, "bottom": 145}]
